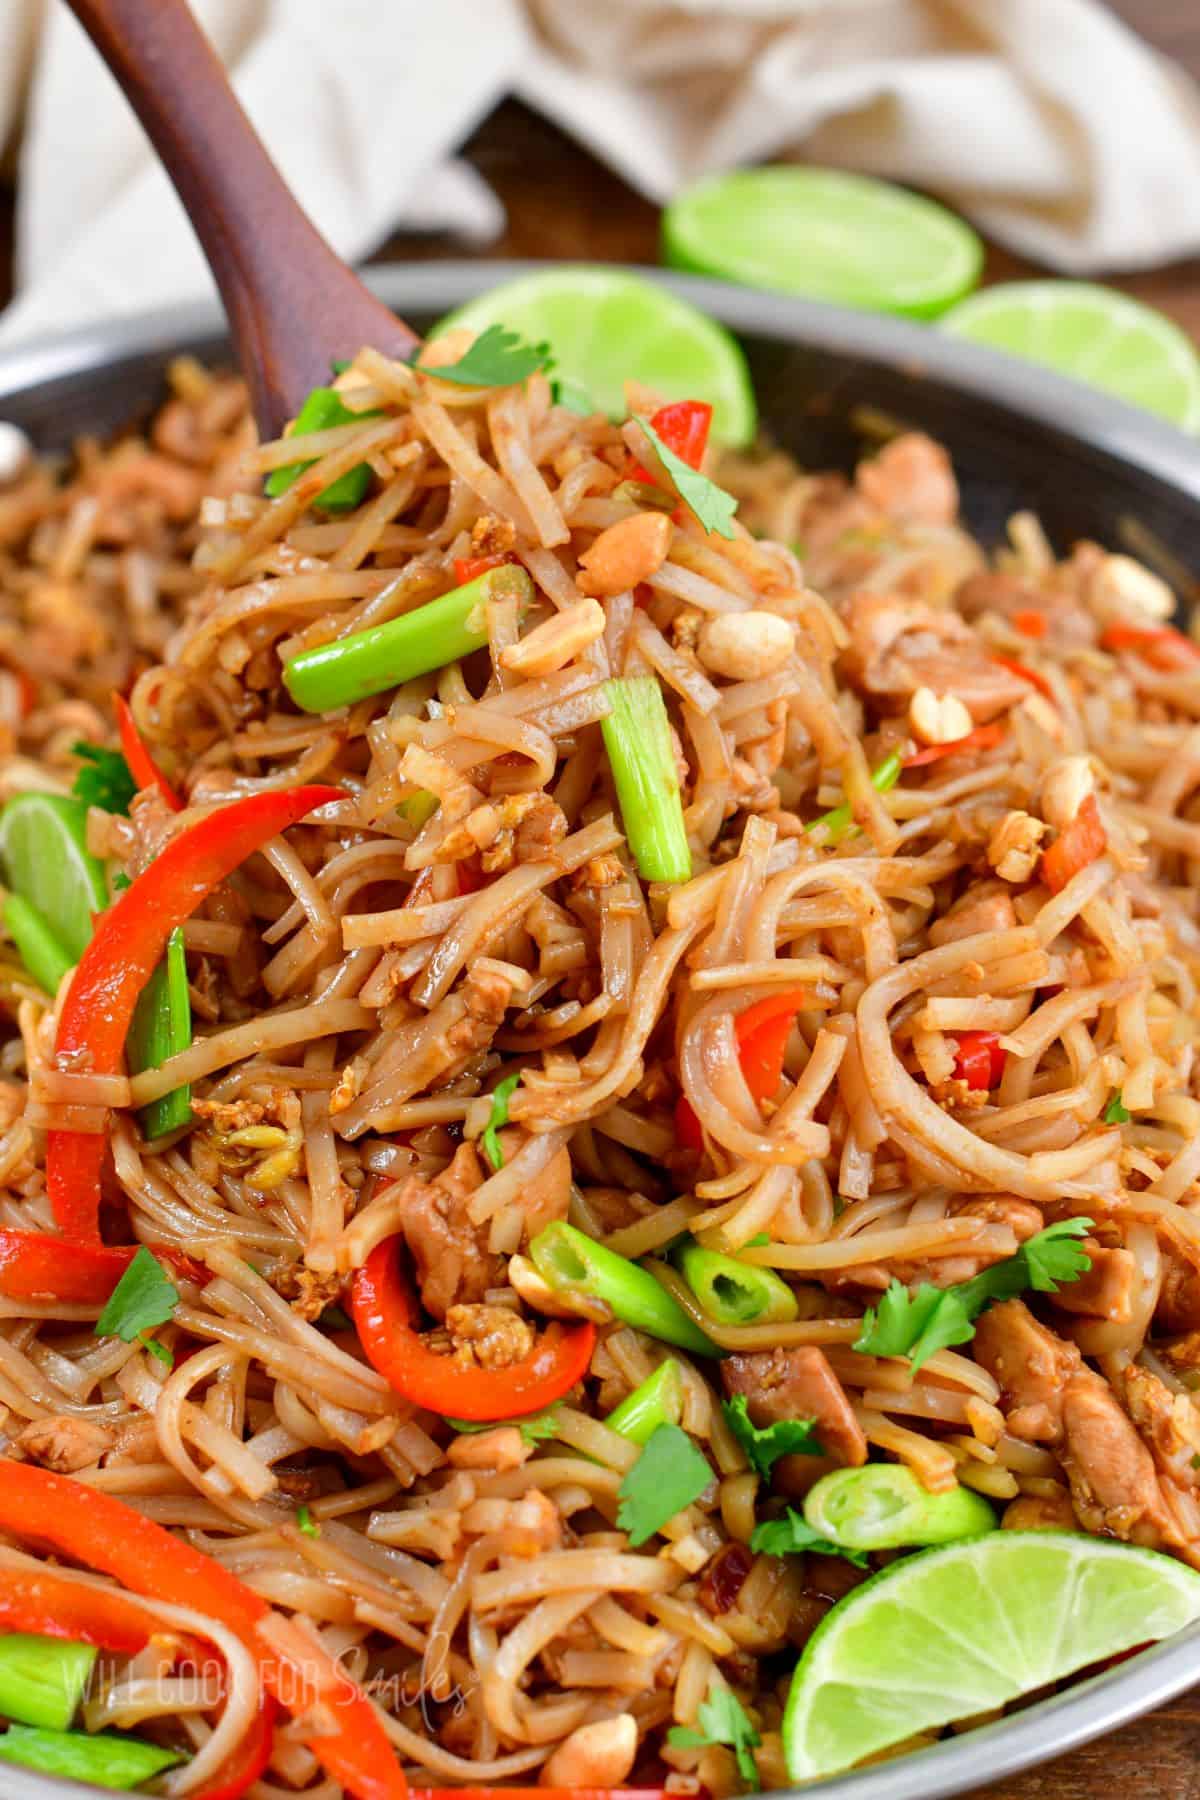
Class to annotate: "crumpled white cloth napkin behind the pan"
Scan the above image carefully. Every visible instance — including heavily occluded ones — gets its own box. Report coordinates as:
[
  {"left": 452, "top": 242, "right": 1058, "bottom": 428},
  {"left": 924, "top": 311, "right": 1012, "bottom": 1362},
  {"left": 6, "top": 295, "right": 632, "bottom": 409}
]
[{"left": 0, "top": 0, "right": 1200, "bottom": 342}]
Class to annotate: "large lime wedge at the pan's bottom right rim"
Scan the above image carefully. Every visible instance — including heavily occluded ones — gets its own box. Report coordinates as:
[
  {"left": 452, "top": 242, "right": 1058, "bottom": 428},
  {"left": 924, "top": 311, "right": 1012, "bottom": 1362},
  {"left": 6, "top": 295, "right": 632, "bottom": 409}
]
[{"left": 783, "top": 1532, "right": 1200, "bottom": 1782}]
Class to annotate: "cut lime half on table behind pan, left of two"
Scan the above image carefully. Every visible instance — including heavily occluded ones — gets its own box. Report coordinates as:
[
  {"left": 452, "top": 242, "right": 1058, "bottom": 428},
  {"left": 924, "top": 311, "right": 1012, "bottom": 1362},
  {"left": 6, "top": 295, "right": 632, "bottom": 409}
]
[{"left": 662, "top": 164, "right": 984, "bottom": 319}]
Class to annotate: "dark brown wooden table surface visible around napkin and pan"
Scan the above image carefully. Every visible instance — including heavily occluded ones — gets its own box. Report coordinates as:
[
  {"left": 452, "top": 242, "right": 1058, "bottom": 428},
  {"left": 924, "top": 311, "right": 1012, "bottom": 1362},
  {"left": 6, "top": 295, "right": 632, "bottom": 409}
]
[{"left": 0, "top": 0, "right": 1200, "bottom": 1800}]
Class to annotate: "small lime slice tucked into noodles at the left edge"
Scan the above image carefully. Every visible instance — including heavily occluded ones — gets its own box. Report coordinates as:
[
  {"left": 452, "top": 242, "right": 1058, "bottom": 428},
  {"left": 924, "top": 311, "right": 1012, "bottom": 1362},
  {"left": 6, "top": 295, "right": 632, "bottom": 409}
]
[{"left": 0, "top": 794, "right": 108, "bottom": 963}]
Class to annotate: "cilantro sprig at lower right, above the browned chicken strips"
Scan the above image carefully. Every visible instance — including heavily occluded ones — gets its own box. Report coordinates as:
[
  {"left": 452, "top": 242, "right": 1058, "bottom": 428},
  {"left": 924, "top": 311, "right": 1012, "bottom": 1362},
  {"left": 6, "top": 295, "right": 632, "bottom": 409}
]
[{"left": 855, "top": 1219, "right": 1092, "bottom": 1375}]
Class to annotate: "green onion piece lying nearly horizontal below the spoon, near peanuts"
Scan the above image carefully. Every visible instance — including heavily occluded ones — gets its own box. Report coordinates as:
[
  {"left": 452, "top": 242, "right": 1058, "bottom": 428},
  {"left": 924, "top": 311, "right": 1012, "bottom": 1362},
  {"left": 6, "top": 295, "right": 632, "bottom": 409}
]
[{"left": 284, "top": 563, "right": 533, "bottom": 713}]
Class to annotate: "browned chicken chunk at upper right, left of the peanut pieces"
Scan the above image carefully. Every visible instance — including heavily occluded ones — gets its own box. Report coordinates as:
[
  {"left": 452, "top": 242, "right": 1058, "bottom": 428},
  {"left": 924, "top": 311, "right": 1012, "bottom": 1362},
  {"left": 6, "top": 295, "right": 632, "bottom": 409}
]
[{"left": 842, "top": 589, "right": 1031, "bottom": 725}]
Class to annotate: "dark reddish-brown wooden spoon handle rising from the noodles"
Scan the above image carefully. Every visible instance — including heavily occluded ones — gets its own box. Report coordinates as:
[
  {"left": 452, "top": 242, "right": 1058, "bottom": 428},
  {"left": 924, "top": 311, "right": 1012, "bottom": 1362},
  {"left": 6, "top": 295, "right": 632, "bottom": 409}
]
[{"left": 68, "top": 0, "right": 419, "bottom": 437}]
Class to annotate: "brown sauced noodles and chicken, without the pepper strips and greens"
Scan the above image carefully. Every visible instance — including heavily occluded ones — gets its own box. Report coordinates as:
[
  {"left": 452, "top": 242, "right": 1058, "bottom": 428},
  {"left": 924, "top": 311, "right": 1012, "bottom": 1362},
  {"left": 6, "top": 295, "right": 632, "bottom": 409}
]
[{"left": 0, "top": 351, "right": 1200, "bottom": 1800}]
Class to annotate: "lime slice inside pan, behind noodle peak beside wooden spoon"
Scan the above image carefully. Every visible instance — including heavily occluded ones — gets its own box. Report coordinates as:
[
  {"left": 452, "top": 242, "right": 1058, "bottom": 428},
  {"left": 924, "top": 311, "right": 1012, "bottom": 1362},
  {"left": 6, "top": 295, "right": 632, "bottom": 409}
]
[{"left": 430, "top": 265, "right": 757, "bottom": 446}]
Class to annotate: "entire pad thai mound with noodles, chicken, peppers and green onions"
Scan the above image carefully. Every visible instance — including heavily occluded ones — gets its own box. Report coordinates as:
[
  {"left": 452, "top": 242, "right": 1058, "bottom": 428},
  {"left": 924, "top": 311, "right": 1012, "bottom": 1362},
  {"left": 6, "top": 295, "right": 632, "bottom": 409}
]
[{"left": 0, "top": 331, "right": 1200, "bottom": 1800}]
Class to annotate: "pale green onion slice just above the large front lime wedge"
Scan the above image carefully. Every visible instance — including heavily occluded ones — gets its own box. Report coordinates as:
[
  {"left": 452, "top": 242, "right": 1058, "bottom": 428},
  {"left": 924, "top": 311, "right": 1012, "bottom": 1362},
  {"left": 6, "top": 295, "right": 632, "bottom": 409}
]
[{"left": 804, "top": 1463, "right": 997, "bottom": 1550}]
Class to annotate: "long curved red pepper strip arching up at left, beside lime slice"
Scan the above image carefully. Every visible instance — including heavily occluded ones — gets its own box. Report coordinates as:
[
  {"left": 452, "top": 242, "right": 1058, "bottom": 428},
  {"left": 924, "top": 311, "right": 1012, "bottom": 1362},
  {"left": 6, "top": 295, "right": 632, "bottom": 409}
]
[{"left": 45, "top": 785, "right": 342, "bottom": 1238}]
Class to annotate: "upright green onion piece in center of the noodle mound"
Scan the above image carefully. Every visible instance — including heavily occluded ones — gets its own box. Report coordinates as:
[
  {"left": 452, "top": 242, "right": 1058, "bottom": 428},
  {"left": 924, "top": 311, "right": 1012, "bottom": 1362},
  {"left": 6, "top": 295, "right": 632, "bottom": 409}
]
[{"left": 601, "top": 675, "right": 691, "bottom": 882}]
